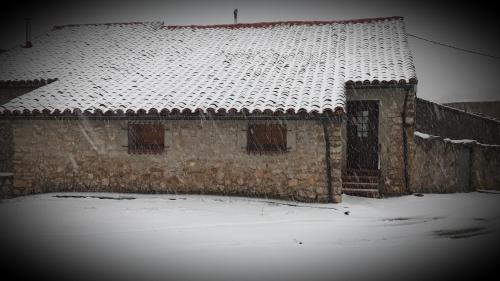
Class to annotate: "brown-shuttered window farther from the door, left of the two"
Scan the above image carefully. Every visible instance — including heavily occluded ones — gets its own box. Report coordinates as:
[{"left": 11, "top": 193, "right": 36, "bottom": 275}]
[{"left": 128, "top": 123, "right": 165, "bottom": 154}]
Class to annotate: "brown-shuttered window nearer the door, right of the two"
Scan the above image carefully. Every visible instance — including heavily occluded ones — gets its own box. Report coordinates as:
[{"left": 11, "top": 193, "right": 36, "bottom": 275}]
[{"left": 247, "top": 124, "right": 287, "bottom": 154}]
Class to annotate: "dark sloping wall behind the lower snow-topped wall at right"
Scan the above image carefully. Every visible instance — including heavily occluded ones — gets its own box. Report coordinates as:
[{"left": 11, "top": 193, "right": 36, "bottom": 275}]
[{"left": 416, "top": 98, "right": 500, "bottom": 144}]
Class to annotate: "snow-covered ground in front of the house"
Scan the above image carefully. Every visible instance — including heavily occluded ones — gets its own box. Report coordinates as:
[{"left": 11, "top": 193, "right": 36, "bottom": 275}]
[{"left": 0, "top": 193, "right": 500, "bottom": 280}]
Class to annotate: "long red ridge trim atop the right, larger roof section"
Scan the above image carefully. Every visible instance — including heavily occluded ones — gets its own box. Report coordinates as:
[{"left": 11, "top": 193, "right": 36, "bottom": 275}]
[{"left": 162, "top": 16, "right": 403, "bottom": 29}]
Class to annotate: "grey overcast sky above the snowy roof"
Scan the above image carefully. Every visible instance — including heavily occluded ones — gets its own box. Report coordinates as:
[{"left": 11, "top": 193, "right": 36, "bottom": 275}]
[{"left": 0, "top": 0, "right": 500, "bottom": 102}]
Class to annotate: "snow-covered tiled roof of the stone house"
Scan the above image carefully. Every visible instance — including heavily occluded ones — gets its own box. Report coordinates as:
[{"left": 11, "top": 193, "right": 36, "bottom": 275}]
[{"left": 0, "top": 17, "right": 417, "bottom": 114}]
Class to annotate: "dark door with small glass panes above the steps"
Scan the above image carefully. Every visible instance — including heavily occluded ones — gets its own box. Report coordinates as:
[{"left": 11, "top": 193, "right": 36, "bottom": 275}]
[{"left": 347, "top": 101, "right": 379, "bottom": 170}]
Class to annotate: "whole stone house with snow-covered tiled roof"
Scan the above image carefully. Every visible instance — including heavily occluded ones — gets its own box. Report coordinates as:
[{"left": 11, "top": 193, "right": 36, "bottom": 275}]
[{"left": 0, "top": 17, "right": 417, "bottom": 202}]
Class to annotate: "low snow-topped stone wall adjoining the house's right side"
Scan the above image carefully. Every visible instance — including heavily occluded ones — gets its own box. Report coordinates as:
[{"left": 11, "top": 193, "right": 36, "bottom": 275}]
[{"left": 410, "top": 132, "right": 500, "bottom": 193}]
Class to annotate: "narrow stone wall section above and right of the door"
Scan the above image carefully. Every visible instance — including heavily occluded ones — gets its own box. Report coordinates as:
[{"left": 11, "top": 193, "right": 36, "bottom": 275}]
[{"left": 344, "top": 87, "right": 415, "bottom": 195}]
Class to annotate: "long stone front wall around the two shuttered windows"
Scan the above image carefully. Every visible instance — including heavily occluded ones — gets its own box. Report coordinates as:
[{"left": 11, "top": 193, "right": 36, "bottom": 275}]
[{"left": 3, "top": 119, "right": 342, "bottom": 202}]
